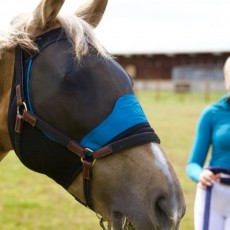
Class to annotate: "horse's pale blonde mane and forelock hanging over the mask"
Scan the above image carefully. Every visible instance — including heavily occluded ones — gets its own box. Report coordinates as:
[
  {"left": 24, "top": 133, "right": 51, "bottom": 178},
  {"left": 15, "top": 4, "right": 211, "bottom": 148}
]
[{"left": 0, "top": 14, "right": 111, "bottom": 59}]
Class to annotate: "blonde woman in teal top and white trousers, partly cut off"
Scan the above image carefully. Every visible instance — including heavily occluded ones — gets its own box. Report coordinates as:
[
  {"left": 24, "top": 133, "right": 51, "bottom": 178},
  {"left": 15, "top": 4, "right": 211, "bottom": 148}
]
[{"left": 186, "top": 58, "right": 230, "bottom": 230}]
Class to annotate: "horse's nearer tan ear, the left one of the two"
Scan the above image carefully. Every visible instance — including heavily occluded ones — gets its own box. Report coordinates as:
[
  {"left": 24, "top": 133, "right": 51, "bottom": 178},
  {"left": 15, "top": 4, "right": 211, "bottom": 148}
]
[{"left": 26, "top": 0, "right": 65, "bottom": 33}]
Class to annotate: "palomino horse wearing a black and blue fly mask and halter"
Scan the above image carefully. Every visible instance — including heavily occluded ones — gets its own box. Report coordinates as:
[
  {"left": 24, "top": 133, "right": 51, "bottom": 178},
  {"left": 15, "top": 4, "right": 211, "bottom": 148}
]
[{"left": 0, "top": 0, "right": 186, "bottom": 230}]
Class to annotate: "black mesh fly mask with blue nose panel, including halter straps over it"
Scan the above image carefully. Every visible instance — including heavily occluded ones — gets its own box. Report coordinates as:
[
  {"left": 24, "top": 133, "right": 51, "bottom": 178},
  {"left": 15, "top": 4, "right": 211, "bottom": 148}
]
[{"left": 8, "top": 28, "right": 159, "bottom": 209}]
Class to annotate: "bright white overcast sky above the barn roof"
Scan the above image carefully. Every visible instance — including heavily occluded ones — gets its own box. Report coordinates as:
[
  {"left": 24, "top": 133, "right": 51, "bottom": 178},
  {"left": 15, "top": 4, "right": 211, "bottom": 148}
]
[{"left": 0, "top": 0, "right": 230, "bottom": 54}]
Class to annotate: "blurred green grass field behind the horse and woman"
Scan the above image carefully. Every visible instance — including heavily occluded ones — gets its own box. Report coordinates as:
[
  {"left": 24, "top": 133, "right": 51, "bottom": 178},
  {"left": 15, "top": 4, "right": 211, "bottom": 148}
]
[{"left": 0, "top": 91, "right": 224, "bottom": 230}]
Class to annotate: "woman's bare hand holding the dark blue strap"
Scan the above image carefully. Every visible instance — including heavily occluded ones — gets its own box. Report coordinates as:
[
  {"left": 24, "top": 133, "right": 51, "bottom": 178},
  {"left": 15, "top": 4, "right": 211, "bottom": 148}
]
[{"left": 198, "top": 169, "right": 220, "bottom": 189}]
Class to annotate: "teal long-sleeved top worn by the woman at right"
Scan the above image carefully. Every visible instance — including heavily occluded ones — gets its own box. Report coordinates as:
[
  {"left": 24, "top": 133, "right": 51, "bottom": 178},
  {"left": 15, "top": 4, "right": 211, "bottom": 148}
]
[{"left": 186, "top": 95, "right": 230, "bottom": 182}]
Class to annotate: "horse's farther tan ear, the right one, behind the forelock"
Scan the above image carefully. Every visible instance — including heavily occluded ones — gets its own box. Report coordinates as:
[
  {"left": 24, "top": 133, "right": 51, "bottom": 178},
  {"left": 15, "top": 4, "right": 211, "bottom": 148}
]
[{"left": 75, "top": 0, "right": 108, "bottom": 27}]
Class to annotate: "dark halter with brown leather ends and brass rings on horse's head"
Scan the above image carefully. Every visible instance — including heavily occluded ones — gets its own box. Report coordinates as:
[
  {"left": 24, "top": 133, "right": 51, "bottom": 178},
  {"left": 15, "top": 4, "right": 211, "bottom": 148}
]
[{"left": 10, "top": 28, "right": 160, "bottom": 210}]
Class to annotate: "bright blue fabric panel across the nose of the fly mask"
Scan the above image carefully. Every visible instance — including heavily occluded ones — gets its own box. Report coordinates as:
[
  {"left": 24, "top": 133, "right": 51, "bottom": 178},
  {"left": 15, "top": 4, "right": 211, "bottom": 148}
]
[{"left": 80, "top": 94, "right": 148, "bottom": 150}]
